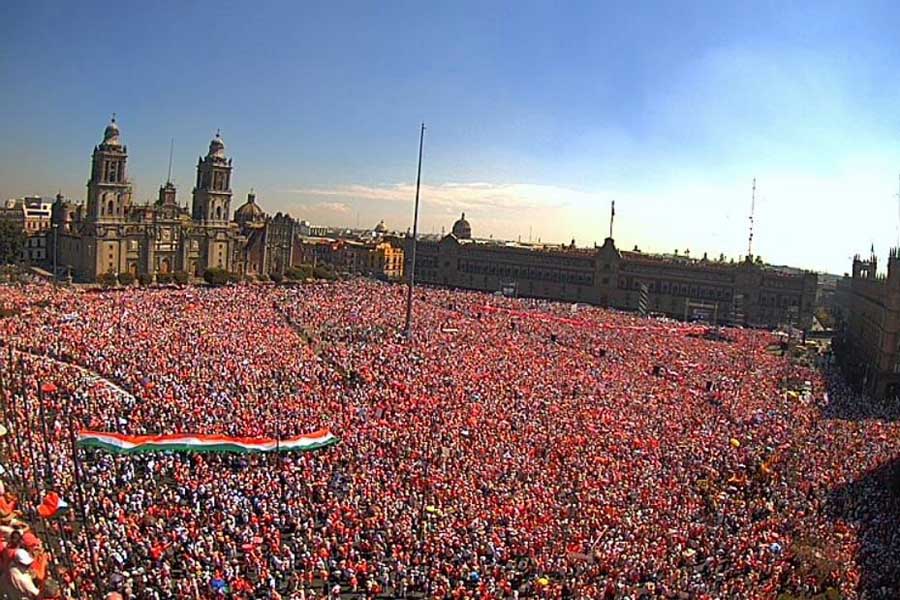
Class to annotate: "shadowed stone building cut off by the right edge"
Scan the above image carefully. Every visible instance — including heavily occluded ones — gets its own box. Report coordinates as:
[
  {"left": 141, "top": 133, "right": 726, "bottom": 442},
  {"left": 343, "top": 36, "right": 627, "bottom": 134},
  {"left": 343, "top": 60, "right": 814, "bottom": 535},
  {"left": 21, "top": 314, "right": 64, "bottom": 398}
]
[{"left": 835, "top": 248, "right": 900, "bottom": 398}]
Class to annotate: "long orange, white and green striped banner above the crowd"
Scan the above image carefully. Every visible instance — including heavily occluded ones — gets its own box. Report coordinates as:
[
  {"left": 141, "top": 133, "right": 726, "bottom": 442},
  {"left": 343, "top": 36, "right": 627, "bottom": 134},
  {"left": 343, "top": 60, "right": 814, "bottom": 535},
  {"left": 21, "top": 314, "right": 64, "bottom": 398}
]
[{"left": 78, "top": 429, "right": 338, "bottom": 454}]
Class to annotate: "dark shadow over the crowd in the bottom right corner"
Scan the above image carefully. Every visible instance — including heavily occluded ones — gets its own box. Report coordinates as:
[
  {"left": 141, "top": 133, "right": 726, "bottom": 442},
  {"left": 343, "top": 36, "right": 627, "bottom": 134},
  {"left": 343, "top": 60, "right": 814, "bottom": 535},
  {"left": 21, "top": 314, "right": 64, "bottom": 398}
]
[{"left": 828, "top": 457, "right": 900, "bottom": 600}]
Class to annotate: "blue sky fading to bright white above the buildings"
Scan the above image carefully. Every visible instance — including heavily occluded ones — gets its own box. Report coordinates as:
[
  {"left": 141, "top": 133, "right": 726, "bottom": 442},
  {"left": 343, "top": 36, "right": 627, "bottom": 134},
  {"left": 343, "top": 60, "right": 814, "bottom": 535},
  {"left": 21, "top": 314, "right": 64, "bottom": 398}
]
[{"left": 0, "top": 1, "right": 900, "bottom": 272}]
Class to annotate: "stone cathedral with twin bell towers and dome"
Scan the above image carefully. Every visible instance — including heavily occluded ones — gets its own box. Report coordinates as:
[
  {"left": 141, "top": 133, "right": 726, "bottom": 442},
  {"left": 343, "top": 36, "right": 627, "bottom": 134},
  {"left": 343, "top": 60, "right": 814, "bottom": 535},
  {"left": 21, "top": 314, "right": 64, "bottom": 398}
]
[{"left": 48, "top": 117, "right": 295, "bottom": 281}]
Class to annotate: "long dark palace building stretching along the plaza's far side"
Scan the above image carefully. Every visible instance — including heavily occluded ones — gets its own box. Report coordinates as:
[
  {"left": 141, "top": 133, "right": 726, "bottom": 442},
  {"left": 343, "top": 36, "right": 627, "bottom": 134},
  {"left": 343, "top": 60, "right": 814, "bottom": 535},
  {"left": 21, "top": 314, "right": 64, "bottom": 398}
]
[{"left": 406, "top": 215, "right": 816, "bottom": 329}]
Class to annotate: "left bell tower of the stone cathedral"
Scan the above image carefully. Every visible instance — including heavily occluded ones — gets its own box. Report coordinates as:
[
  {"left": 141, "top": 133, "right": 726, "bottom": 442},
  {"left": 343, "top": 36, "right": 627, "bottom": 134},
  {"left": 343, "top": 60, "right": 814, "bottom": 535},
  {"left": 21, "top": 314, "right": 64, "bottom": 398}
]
[{"left": 87, "top": 115, "right": 131, "bottom": 223}]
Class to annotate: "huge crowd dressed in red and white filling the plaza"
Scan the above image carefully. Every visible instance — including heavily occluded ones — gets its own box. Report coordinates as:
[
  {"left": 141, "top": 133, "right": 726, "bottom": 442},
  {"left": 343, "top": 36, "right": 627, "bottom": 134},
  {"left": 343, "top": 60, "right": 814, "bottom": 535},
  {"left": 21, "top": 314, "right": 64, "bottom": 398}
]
[{"left": 0, "top": 280, "right": 900, "bottom": 600}]
